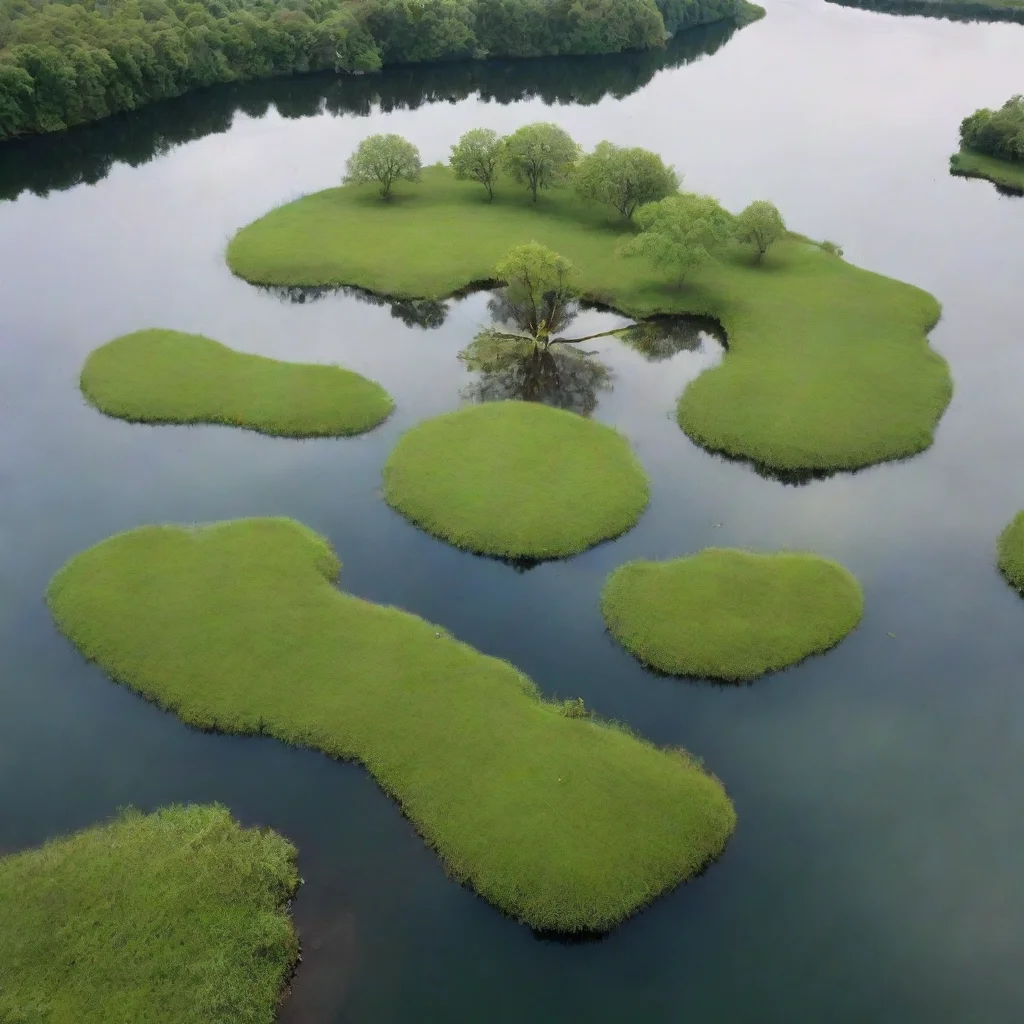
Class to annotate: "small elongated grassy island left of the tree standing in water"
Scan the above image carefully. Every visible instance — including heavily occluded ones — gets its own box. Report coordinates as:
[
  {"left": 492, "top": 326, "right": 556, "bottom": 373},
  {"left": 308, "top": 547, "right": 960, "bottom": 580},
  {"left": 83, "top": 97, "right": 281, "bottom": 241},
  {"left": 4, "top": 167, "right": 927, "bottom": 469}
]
[{"left": 81, "top": 330, "right": 393, "bottom": 437}]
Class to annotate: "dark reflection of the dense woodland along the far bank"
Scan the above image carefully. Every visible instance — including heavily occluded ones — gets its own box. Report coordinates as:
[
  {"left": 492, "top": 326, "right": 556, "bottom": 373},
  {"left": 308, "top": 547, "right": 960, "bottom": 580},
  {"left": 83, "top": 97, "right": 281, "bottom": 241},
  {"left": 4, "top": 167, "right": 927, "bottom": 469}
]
[{"left": 0, "top": 22, "right": 736, "bottom": 200}]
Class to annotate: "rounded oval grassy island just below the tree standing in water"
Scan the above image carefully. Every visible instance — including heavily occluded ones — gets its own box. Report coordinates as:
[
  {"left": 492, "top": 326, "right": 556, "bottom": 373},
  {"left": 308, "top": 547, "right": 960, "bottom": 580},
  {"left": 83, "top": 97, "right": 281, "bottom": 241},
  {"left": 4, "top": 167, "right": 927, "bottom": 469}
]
[{"left": 384, "top": 401, "right": 649, "bottom": 558}]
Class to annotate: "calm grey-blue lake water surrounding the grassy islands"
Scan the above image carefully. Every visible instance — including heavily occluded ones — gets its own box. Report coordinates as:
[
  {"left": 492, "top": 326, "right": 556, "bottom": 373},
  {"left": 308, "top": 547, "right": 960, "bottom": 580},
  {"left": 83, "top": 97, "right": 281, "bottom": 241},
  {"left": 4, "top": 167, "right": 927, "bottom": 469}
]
[{"left": 0, "top": 0, "right": 1024, "bottom": 1024}]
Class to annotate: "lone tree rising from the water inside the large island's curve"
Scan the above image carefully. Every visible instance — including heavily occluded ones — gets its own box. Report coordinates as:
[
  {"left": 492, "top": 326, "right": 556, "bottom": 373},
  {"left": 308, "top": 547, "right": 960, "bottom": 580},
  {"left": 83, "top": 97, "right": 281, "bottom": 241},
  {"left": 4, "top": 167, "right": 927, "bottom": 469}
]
[{"left": 496, "top": 242, "right": 575, "bottom": 348}]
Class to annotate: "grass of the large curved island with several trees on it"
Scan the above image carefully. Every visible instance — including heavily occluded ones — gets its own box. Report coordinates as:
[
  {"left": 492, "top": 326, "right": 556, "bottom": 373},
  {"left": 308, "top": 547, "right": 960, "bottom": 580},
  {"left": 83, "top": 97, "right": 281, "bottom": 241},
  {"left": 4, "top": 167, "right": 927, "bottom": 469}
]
[{"left": 227, "top": 167, "right": 952, "bottom": 472}]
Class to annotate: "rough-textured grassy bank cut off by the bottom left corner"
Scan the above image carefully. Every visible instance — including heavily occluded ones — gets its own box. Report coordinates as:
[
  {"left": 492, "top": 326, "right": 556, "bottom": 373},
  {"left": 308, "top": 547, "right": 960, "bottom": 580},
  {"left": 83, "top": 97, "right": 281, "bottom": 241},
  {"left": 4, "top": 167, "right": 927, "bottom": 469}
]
[{"left": 0, "top": 806, "right": 299, "bottom": 1024}]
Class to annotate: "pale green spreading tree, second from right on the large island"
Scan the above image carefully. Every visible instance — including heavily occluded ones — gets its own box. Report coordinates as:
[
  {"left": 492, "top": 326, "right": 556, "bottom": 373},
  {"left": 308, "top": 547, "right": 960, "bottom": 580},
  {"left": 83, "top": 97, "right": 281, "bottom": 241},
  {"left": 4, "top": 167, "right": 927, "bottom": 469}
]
[{"left": 621, "top": 193, "right": 733, "bottom": 285}]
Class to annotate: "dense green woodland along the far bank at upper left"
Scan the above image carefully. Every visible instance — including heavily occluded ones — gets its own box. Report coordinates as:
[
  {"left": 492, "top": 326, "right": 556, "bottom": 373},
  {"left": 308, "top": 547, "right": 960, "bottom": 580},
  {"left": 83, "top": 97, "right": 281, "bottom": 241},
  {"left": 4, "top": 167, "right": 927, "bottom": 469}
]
[{"left": 0, "top": 0, "right": 746, "bottom": 139}]
